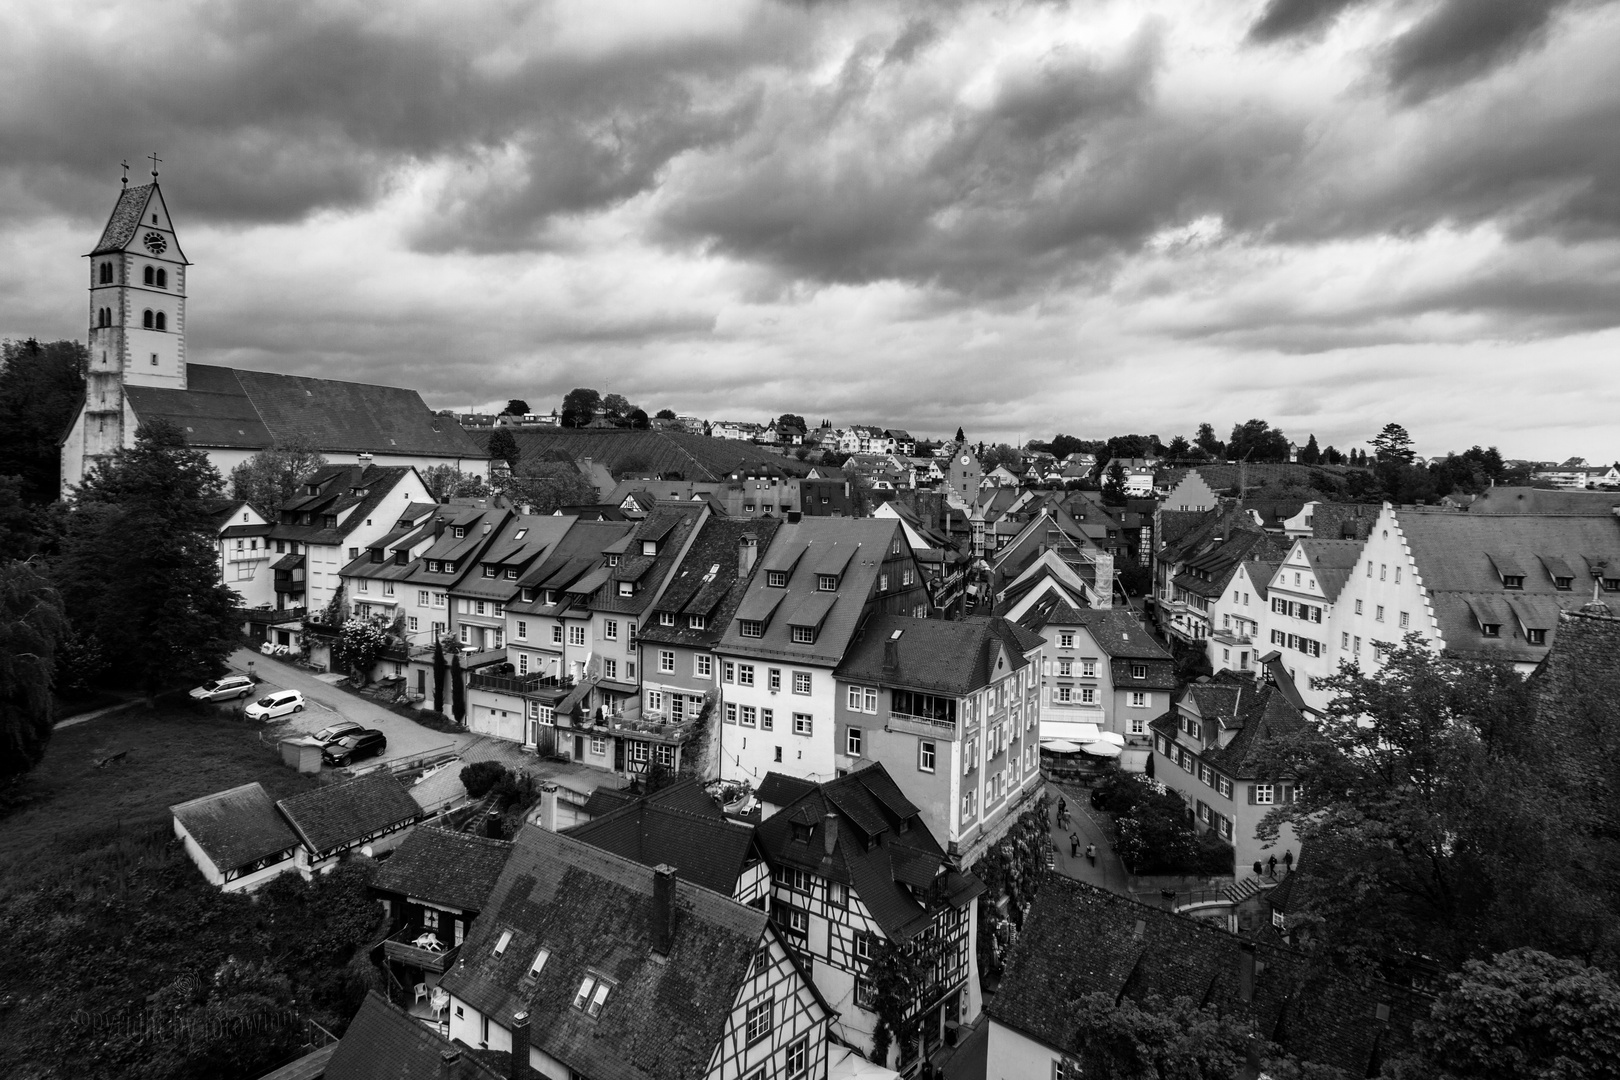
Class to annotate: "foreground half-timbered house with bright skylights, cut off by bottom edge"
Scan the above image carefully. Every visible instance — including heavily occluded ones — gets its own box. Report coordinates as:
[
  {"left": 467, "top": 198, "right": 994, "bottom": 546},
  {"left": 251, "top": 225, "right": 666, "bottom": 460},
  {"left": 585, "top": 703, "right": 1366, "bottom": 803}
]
[{"left": 441, "top": 826, "right": 831, "bottom": 1080}]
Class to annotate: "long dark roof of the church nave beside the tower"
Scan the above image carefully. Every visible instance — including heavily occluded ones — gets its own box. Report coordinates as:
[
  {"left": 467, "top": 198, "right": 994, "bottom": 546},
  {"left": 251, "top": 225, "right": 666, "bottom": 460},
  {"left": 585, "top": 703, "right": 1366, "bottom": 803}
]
[{"left": 125, "top": 364, "right": 486, "bottom": 458}]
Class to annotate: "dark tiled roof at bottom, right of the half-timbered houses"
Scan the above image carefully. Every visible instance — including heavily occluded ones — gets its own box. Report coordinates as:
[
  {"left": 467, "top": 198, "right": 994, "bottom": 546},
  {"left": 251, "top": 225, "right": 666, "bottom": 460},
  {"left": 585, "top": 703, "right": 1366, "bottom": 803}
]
[{"left": 987, "top": 874, "right": 1430, "bottom": 1077}]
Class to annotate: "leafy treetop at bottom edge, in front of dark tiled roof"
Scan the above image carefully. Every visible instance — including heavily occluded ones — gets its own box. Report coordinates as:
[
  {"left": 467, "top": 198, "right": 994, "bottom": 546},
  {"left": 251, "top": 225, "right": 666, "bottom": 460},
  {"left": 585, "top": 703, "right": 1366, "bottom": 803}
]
[{"left": 1064, "top": 993, "right": 1251, "bottom": 1080}]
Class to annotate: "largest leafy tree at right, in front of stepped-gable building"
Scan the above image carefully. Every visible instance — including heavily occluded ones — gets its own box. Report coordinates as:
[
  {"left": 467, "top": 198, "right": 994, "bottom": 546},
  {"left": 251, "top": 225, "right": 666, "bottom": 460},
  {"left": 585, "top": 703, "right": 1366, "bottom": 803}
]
[{"left": 1257, "top": 635, "right": 1620, "bottom": 972}]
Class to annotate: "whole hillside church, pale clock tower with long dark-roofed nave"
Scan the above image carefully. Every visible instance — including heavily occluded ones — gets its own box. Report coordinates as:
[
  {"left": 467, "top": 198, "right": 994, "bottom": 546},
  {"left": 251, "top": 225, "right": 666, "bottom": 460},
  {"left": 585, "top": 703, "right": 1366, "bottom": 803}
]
[{"left": 62, "top": 175, "right": 489, "bottom": 494}]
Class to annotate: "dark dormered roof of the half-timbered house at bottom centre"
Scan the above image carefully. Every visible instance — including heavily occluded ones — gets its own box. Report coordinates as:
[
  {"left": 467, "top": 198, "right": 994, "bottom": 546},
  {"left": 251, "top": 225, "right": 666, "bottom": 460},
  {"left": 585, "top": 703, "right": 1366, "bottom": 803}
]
[{"left": 758, "top": 763, "right": 985, "bottom": 942}]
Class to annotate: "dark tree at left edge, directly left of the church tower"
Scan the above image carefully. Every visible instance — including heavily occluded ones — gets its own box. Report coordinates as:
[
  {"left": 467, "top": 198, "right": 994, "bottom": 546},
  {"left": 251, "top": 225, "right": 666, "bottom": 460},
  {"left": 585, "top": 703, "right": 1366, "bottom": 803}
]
[{"left": 0, "top": 338, "right": 89, "bottom": 505}]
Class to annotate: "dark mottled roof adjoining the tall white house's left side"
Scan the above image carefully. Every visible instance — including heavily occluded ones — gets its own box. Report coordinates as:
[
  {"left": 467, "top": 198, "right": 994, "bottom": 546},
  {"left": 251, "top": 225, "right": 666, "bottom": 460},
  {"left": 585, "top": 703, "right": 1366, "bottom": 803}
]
[{"left": 637, "top": 517, "right": 781, "bottom": 648}]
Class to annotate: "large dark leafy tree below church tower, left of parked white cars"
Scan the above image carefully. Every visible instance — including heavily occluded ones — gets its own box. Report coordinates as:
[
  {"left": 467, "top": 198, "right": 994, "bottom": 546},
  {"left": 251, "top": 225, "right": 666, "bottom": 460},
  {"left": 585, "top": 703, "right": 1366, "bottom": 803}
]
[{"left": 53, "top": 421, "right": 238, "bottom": 703}]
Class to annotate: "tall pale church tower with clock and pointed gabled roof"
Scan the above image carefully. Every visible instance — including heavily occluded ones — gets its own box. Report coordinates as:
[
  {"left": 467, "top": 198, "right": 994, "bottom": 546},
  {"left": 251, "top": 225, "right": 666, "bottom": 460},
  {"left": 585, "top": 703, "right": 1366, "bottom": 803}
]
[{"left": 82, "top": 159, "right": 190, "bottom": 479}]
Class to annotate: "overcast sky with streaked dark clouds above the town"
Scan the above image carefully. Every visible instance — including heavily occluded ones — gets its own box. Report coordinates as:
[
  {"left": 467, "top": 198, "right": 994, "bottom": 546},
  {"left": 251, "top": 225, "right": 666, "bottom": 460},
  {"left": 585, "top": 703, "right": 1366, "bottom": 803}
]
[{"left": 0, "top": 0, "right": 1620, "bottom": 461}]
